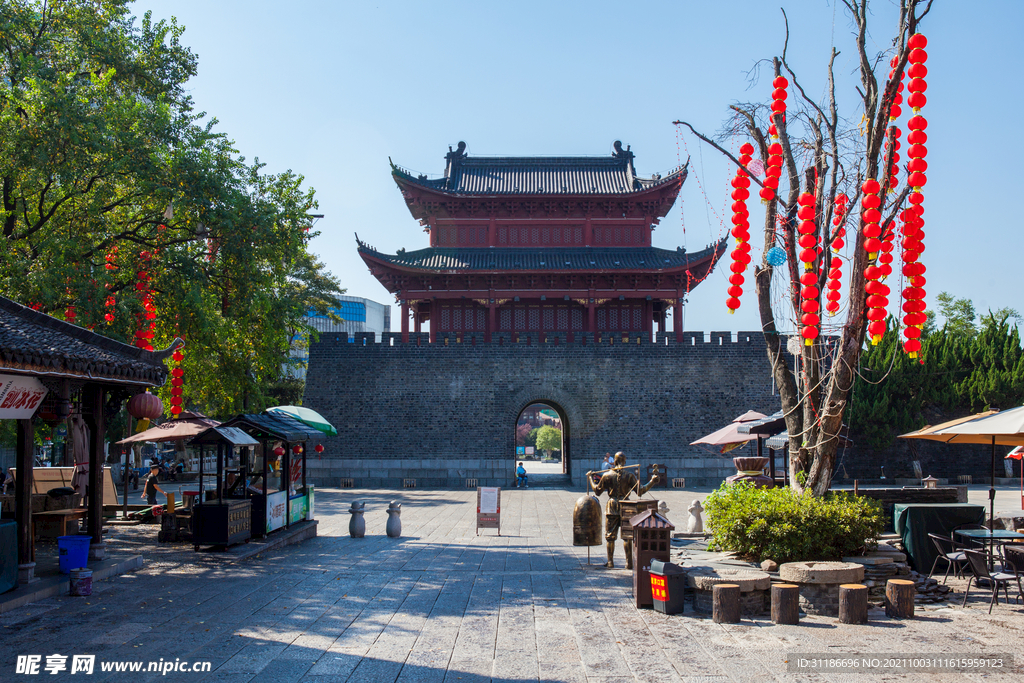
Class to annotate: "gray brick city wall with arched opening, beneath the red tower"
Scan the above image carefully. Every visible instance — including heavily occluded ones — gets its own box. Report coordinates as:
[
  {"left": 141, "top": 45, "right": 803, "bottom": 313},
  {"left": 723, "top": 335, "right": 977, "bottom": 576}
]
[{"left": 304, "top": 332, "right": 779, "bottom": 487}]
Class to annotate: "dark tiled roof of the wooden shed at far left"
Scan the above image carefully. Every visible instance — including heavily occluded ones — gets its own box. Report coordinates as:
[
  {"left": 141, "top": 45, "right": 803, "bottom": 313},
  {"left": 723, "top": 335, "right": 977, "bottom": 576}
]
[{"left": 0, "top": 297, "right": 180, "bottom": 386}]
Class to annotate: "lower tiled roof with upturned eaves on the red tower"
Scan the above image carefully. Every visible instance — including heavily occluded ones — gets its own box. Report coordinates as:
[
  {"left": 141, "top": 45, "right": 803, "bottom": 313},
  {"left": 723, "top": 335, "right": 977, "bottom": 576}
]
[{"left": 358, "top": 240, "right": 726, "bottom": 272}]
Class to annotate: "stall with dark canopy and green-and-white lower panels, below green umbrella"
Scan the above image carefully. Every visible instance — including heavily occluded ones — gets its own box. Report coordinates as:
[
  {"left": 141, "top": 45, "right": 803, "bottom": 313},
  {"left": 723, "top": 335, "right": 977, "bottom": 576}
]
[{"left": 223, "top": 413, "right": 323, "bottom": 537}]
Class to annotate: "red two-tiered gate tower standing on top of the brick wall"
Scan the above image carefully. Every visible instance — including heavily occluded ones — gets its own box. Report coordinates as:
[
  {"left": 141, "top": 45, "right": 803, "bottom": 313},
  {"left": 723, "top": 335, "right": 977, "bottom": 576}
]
[{"left": 359, "top": 142, "right": 725, "bottom": 342}]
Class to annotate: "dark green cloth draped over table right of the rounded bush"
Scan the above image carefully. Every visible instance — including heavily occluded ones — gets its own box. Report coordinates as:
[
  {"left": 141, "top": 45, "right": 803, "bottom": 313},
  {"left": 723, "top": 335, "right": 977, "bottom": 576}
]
[{"left": 893, "top": 503, "right": 985, "bottom": 573}]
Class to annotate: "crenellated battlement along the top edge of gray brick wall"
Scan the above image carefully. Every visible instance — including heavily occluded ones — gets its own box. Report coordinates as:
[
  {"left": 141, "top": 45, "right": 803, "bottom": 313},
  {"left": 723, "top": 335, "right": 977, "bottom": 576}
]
[{"left": 315, "top": 331, "right": 764, "bottom": 348}]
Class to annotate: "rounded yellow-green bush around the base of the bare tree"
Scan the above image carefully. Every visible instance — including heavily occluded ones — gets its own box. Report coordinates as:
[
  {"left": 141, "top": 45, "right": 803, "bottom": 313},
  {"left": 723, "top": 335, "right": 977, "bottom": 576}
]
[{"left": 703, "top": 481, "right": 884, "bottom": 563}]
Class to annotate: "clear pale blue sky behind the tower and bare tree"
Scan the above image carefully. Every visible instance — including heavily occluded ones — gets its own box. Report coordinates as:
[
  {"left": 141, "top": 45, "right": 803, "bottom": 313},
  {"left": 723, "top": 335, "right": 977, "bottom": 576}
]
[{"left": 134, "top": 0, "right": 1024, "bottom": 331}]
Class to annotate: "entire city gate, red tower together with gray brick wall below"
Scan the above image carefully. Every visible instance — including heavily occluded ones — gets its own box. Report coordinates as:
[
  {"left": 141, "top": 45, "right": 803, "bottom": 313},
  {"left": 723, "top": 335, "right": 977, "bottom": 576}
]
[{"left": 304, "top": 142, "right": 777, "bottom": 486}]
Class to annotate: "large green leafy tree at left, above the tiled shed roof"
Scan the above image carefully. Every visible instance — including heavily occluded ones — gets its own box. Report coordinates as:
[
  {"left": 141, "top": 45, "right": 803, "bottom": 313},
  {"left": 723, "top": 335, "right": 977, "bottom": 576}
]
[{"left": 0, "top": 0, "right": 340, "bottom": 414}]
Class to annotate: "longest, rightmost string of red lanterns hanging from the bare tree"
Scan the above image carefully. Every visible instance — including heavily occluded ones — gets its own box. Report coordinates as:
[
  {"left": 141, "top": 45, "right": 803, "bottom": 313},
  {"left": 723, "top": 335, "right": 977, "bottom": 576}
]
[{"left": 900, "top": 34, "right": 928, "bottom": 358}]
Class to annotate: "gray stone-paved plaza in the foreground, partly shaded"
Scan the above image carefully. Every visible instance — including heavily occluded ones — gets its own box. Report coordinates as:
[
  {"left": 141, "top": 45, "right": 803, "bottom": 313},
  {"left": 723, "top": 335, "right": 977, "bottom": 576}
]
[{"left": 0, "top": 489, "right": 1024, "bottom": 683}]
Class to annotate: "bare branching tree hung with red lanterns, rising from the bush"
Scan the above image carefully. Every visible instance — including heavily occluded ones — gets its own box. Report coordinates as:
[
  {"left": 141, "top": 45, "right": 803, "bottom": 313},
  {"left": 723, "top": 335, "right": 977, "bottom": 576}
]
[{"left": 676, "top": 0, "right": 932, "bottom": 496}]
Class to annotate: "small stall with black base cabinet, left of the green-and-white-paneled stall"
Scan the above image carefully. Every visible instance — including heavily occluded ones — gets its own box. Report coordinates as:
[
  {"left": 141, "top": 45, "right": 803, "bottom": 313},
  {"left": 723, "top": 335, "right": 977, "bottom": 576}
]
[{"left": 191, "top": 426, "right": 259, "bottom": 550}]
